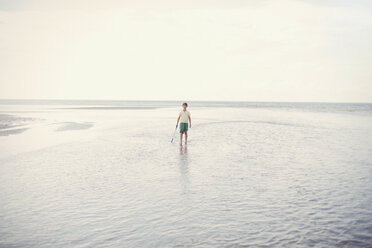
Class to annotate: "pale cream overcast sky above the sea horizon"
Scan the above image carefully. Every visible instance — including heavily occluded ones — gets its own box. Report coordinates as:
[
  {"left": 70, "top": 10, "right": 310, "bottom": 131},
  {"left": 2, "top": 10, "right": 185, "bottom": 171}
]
[{"left": 0, "top": 0, "right": 372, "bottom": 102}]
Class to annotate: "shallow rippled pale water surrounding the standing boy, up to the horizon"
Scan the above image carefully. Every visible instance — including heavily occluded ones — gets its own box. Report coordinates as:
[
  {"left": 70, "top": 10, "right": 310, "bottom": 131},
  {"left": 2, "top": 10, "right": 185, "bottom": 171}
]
[{"left": 0, "top": 100, "right": 372, "bottom": 247}]
